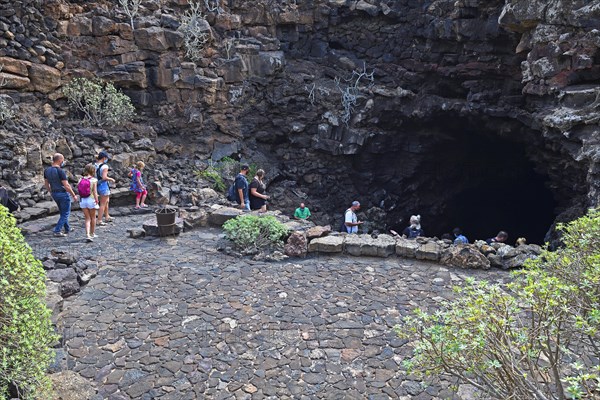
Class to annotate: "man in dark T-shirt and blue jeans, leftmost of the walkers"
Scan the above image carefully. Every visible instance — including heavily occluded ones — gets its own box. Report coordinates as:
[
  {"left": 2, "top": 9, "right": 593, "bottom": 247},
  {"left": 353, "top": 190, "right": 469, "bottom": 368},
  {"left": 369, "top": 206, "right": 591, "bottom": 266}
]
[{"left": 44, "top": 153, "right": 77, "bottom": 237}]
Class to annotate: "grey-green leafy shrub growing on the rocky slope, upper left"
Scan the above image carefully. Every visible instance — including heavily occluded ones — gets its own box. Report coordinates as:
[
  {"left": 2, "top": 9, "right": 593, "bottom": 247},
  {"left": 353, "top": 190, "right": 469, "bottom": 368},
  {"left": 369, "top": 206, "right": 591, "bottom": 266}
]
[{"left": 62, "top": 78, "right": 135, "bottom": 126}]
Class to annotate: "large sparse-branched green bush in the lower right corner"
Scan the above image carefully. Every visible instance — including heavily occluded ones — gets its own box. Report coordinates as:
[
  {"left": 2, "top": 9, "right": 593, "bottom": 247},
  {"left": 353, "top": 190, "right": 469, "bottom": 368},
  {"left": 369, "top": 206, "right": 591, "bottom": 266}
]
[{"left": 396, "top": 210, "right": 600, "bottom": 400}]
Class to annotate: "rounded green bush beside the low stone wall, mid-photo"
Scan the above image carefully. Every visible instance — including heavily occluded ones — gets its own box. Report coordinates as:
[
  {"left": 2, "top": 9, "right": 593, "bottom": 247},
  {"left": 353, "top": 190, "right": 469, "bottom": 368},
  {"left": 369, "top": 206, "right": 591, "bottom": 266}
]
[{"left": 223, "top": 215, "right": 288, "bottom": 254}]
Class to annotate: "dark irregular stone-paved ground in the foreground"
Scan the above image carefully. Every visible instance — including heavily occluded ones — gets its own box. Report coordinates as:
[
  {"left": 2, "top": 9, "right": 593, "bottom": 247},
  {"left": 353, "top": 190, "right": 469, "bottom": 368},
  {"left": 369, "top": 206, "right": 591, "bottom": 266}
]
[{"left": 28, "top": 209, "right": 508, "bottom": 400}]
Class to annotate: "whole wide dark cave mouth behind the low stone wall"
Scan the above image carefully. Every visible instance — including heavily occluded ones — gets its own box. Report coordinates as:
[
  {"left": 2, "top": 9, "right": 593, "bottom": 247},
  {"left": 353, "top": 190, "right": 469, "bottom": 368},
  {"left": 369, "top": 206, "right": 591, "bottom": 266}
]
[{"left": 354, "top": 117, "right": 574, "bottom": 244}]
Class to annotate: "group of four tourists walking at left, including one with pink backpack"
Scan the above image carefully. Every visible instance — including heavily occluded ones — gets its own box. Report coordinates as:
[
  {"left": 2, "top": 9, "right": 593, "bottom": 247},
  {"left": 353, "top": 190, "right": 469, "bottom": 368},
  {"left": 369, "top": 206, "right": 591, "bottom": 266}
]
[{"left": 44, "top": 151, "right": 148, "bottom": 242}]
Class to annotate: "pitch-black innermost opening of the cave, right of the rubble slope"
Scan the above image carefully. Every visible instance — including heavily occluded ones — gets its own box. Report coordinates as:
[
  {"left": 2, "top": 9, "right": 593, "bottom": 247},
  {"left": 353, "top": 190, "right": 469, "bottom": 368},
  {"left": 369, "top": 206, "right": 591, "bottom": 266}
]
[{"left": 432, "top": 131, "right": 557, "bottom": 244}]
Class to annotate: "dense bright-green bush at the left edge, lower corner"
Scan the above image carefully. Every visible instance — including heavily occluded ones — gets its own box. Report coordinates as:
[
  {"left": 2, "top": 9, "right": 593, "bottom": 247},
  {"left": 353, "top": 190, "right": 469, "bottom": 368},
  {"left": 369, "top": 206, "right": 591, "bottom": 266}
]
[{"left": 0, "top": 205, "right": 57, "bottom": 399}]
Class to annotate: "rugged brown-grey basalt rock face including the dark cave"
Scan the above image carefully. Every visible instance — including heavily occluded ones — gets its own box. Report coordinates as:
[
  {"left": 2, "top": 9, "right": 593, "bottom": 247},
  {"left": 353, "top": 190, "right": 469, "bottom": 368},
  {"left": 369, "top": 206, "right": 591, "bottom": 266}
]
[{"left": 0, "top": 0, "right": 600, "bottom": 241}]
